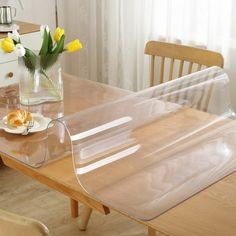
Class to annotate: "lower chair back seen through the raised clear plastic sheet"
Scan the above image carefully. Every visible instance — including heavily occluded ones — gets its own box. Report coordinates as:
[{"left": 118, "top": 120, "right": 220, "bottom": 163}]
[{"left": 149, "top": 67, "right": 229, "bottom": 114}]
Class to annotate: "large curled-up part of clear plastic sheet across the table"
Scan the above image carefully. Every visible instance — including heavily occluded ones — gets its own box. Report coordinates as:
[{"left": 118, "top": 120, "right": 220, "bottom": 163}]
[{"left": 45, "top": 67, "right": 236, "bottom": 220}]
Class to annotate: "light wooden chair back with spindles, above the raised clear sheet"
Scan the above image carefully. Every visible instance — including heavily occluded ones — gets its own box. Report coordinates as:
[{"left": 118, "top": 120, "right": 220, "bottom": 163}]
[{"left": 145, "top": 41, "right": 224, "bottom": 86}]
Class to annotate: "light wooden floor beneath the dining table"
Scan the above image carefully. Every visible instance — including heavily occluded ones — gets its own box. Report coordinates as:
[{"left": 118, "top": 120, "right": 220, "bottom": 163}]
[{"left": 0, "top": 163, "right": 147, "bottom": 236}]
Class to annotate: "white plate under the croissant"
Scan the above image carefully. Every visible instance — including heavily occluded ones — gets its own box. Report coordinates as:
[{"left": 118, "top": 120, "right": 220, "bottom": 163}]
[{"left": 0, "top": 113, "right": 51, "bottom": 134}]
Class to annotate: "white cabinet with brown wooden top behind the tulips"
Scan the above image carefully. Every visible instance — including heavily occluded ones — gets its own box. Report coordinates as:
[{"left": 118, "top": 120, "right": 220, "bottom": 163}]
[{"left": 0, "top": 22, "right": 42, "bottom": 87}]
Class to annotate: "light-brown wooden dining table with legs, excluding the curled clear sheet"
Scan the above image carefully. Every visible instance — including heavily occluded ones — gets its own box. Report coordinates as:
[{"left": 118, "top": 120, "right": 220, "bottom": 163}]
[{"left": 0, "top": 74, "right": 236, "bottom": 236}]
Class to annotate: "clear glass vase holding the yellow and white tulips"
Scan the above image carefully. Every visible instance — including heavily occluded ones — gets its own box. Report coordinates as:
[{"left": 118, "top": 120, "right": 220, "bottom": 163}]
[{"left": 18, "top": 56, "right": 63, "bottom": 105}]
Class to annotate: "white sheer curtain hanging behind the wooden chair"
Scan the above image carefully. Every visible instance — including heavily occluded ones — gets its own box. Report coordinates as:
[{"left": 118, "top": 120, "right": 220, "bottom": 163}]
[{"left": 60, "top": 0, "right": 236, "bottom": 104}]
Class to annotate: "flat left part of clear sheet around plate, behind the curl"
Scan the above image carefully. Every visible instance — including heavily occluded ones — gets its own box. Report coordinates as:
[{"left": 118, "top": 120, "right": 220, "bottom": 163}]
[{"left": 0, "top": 74, "right": 129, "bottom": 168}]
